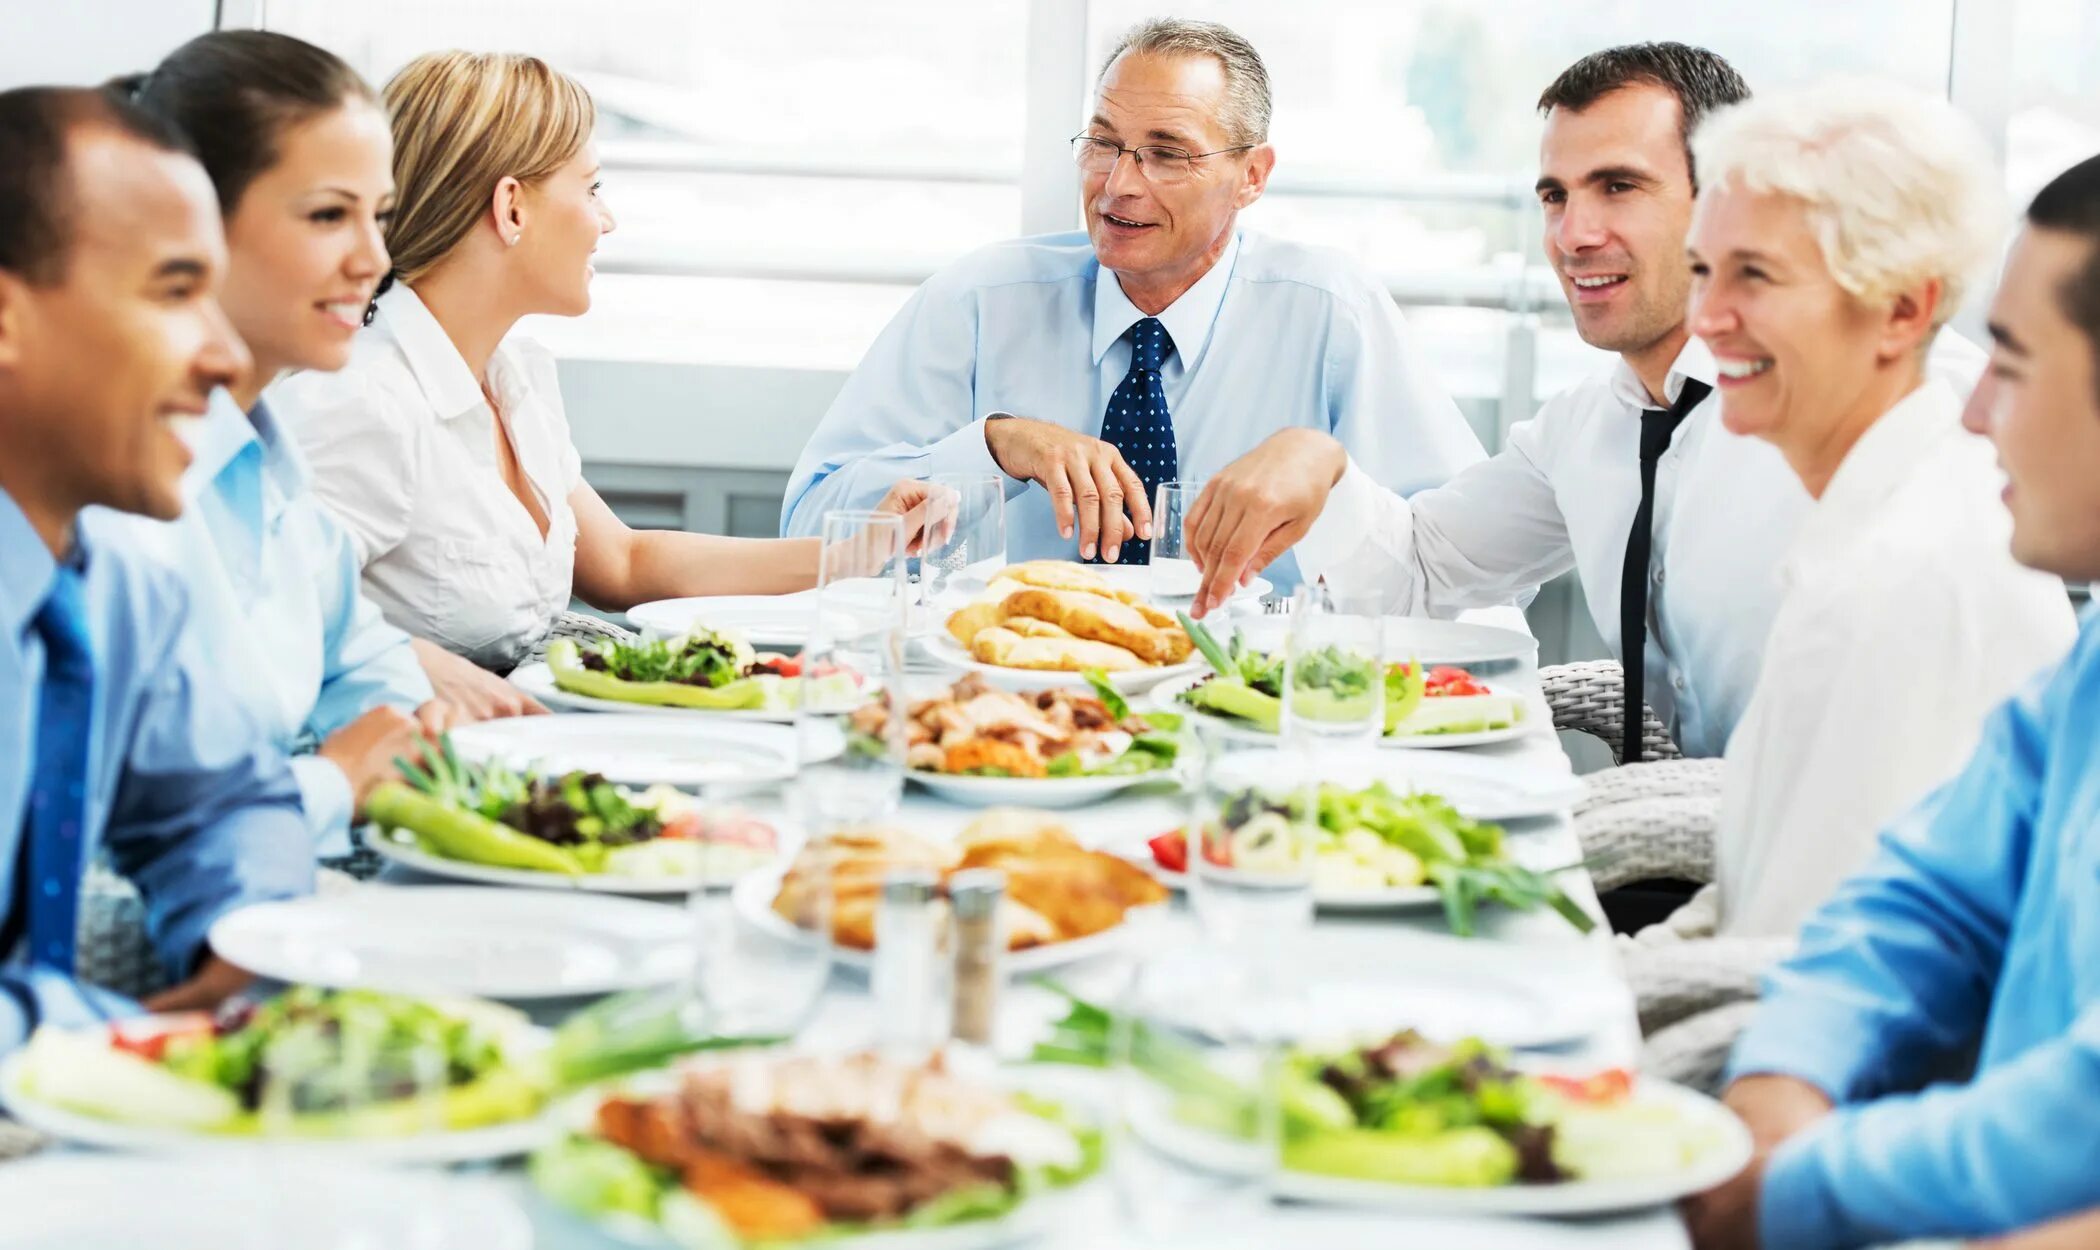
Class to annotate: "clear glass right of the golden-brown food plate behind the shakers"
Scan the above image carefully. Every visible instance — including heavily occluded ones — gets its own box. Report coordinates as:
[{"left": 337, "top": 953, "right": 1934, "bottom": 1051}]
[{"left": 1187, "top": 721, "right": 1317, "bottom": 950}]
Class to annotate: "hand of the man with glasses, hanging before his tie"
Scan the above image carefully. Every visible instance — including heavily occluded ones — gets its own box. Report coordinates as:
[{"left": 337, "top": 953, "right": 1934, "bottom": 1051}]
[{"left": 985, "top": 416, "right": 1153, "bottom": 563}]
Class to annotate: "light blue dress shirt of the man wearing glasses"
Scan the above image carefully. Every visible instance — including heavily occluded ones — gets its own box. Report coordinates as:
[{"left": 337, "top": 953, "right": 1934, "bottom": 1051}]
[{"left": 781, "top": 233, "right": 1483, "bottom": 590}]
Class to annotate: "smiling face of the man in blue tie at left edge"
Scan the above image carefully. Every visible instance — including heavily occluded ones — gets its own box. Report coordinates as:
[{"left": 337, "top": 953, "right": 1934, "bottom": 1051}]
[{"left": 0, "top": 124, "right": 248, "bottom": 531}]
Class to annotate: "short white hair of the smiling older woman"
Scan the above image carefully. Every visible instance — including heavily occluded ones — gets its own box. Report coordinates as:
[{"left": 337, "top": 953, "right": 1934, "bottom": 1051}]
[{"left": 1693, "top": 80, "right": 2006, "bottom": 328}]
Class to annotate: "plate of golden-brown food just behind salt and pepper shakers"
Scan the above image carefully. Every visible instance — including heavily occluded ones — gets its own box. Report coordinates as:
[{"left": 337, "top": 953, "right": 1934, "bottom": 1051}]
[{"left": 737, "top": 809, "right": 1168, "bottom": 971}]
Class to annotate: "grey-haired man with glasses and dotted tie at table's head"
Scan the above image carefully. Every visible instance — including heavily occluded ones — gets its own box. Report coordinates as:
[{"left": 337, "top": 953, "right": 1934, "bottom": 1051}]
[{"left": 781, "top": 21, "right": 1483, "bottom": 588}]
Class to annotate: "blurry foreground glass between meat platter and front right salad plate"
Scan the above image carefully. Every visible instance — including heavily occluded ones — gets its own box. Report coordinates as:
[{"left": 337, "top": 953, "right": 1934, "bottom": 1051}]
[{"left": 1109, "top": 943, "right": 1292, "bottom": 1246}]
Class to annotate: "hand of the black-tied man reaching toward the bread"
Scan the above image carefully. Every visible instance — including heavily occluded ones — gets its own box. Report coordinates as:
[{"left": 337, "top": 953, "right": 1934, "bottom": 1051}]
[{"left": 1182, "top": 429, "right": 1348, "bottom": 616}]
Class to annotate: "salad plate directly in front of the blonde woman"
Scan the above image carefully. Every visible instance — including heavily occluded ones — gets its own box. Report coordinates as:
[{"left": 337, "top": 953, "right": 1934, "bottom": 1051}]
[{"left": 510, "top": 628, "right": 867, "bottom": 723}]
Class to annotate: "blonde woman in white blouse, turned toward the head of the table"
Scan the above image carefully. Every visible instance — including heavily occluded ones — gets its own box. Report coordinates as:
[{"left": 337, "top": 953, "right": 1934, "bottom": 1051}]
[{"left": 271, "top": 53, "right": 924, "bottom": 693}]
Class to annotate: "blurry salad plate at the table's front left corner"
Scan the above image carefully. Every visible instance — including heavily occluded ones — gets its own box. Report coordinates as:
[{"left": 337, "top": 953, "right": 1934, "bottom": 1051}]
[{"left": 0, "top": 985, "right": 561, "bottom": 1164}]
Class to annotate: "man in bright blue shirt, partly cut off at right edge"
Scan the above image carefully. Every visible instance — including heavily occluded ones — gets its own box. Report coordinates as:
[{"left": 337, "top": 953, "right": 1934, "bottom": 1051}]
[{"left": 1688, "top": 158, "right": 2100, "bottom": 1250}]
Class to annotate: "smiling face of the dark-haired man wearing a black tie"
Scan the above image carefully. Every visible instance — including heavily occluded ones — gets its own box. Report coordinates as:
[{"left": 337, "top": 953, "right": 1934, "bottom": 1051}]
[{"left": 1537, "top": 84, "right": 1693, "bottom": 366}]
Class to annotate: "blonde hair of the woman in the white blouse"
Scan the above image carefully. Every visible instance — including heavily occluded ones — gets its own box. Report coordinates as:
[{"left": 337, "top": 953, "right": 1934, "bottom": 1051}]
[{"left": 386, "top": 53, "right": 599, "bottom": 282}]
